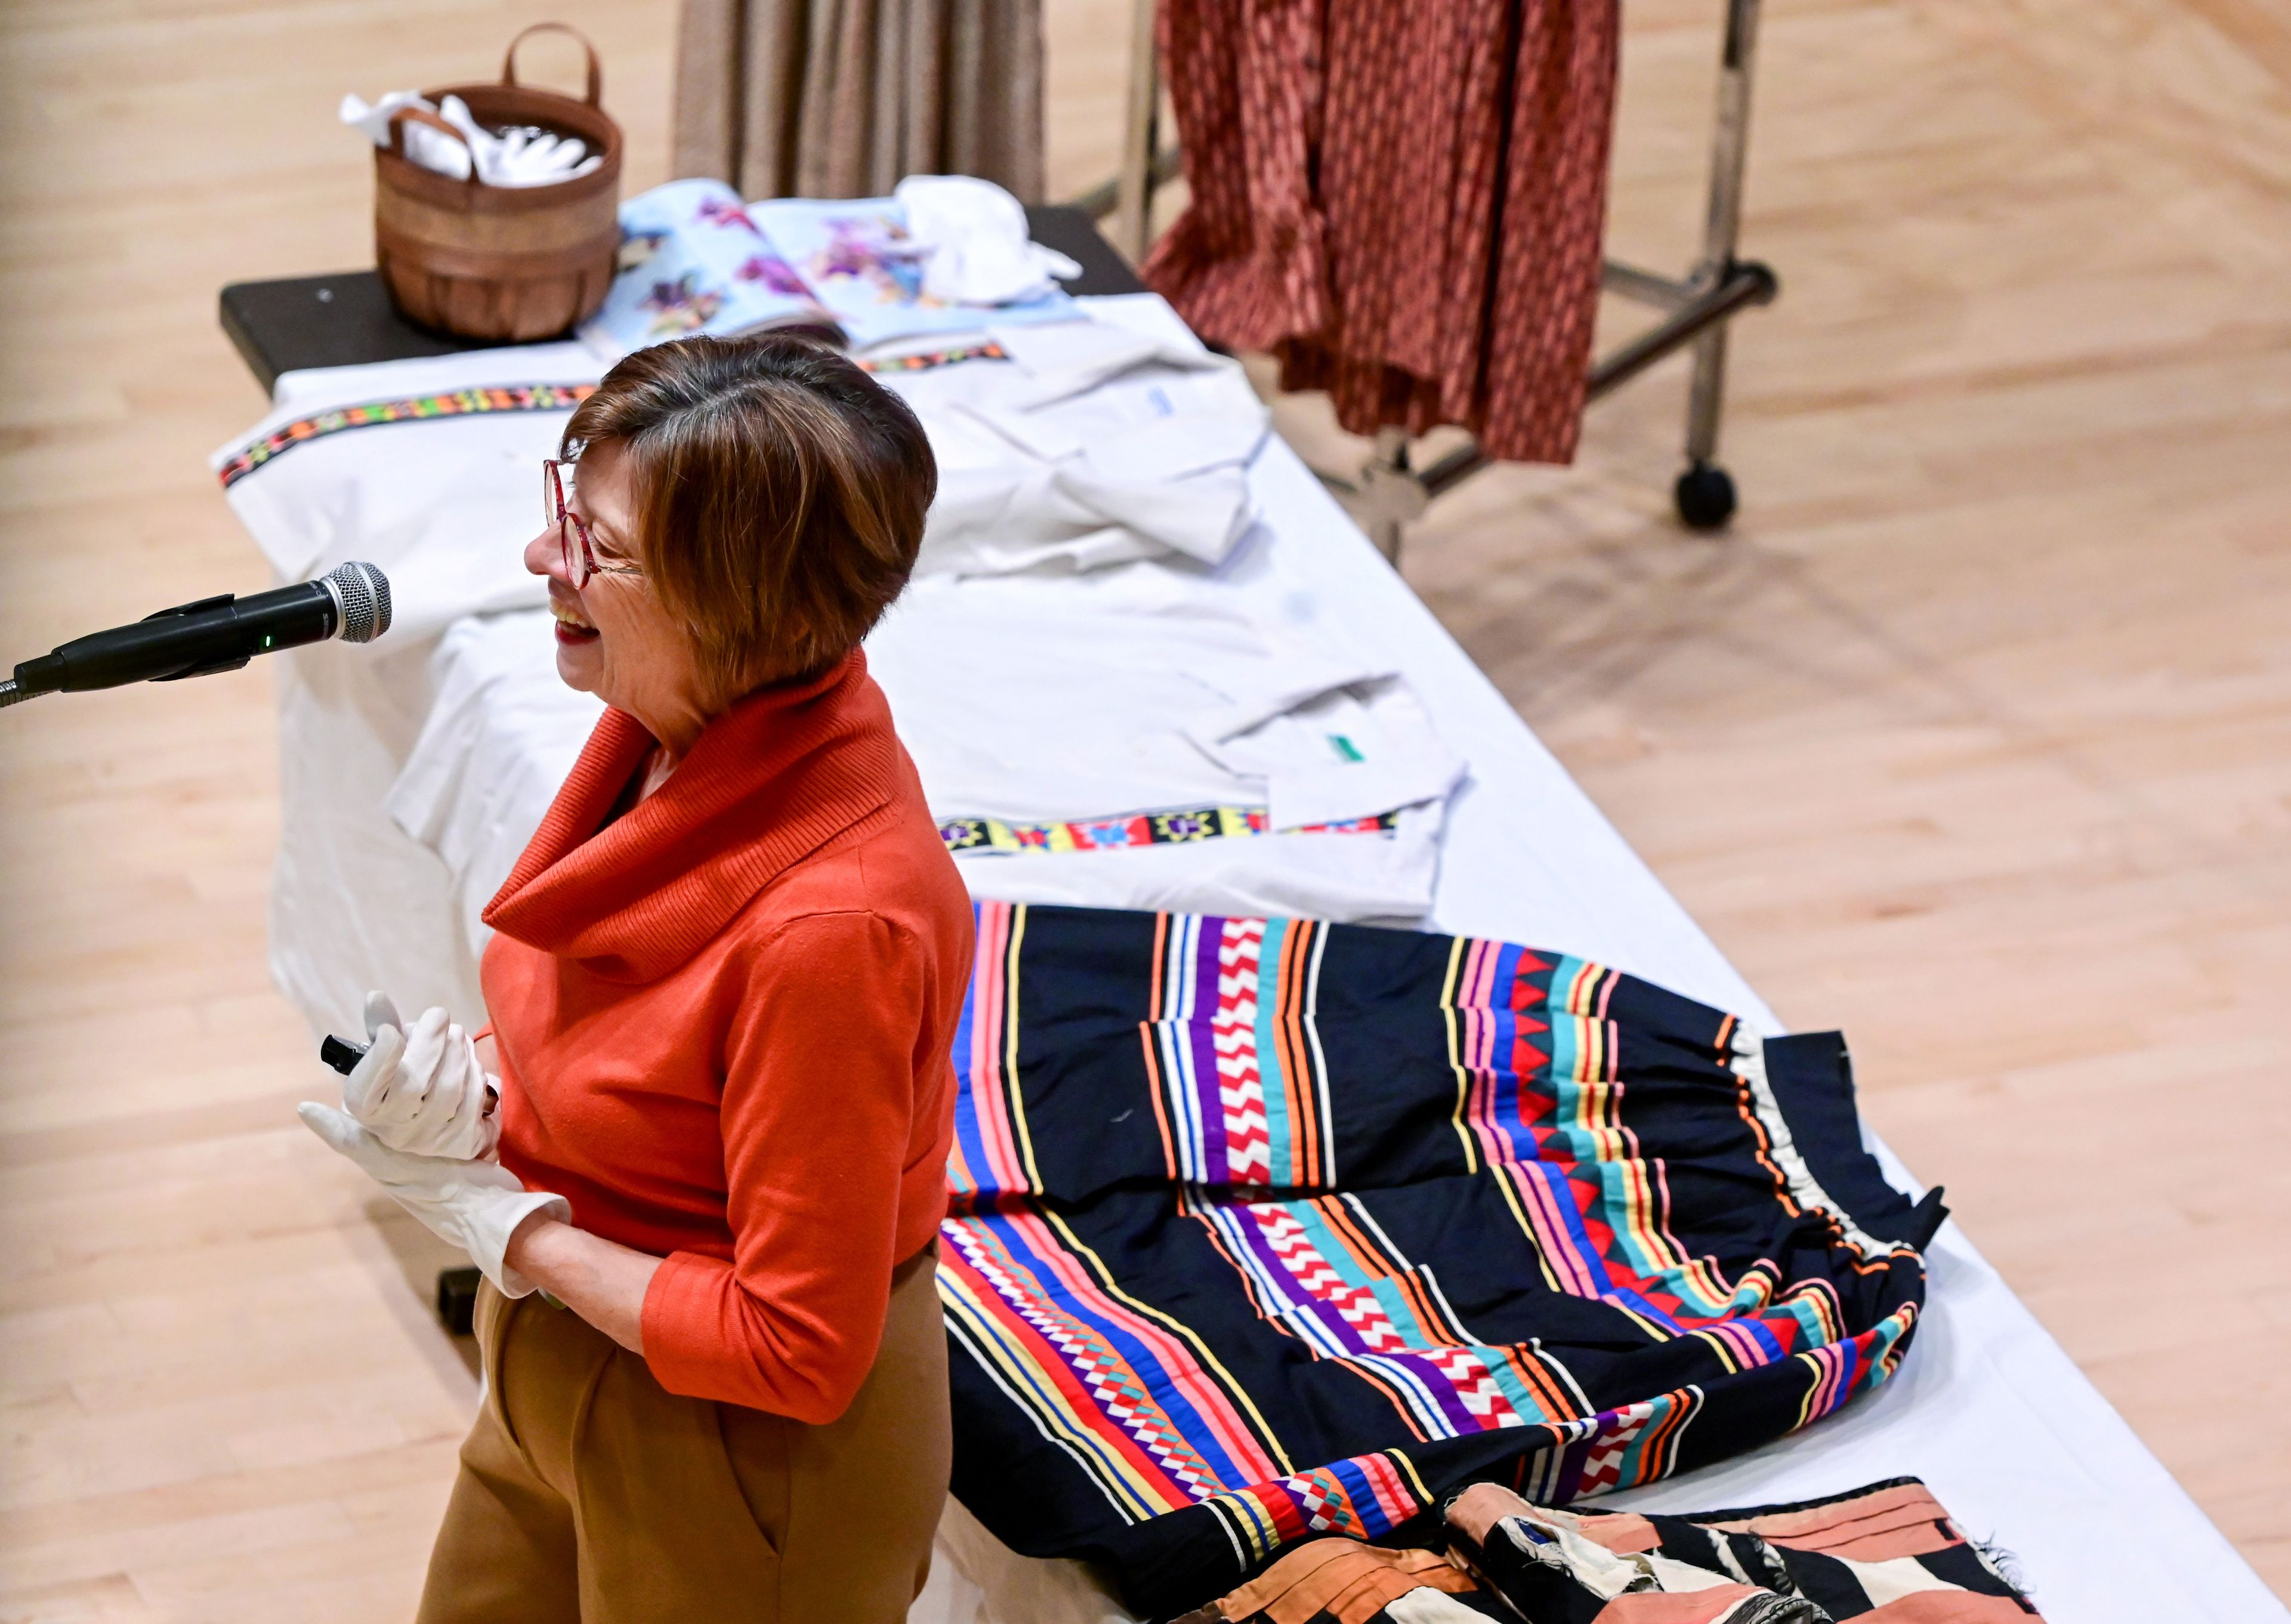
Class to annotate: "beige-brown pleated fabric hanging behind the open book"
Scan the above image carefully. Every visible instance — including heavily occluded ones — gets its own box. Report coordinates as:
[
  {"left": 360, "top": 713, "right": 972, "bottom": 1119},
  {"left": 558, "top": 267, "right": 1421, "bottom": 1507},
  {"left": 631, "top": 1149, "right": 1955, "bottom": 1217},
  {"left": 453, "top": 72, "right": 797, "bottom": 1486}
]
[{"left": 676, "top": 0, "right": 1042, "bottom": 202}]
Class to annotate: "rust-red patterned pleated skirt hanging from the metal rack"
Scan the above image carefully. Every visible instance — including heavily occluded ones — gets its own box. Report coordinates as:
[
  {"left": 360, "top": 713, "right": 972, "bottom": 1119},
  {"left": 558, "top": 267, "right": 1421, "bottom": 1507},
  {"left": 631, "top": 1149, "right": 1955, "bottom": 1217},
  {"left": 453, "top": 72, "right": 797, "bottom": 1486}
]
[{"left": 1143, "top": 0, "right": 1620, "bottom": 463}]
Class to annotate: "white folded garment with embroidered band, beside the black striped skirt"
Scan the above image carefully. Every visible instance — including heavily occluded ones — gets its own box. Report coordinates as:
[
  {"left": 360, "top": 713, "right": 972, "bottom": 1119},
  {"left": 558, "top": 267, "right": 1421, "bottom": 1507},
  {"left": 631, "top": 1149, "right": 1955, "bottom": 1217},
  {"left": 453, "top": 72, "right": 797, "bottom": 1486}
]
[{"left": 868, "top": 563, "right": 1464, "bottom": 919}]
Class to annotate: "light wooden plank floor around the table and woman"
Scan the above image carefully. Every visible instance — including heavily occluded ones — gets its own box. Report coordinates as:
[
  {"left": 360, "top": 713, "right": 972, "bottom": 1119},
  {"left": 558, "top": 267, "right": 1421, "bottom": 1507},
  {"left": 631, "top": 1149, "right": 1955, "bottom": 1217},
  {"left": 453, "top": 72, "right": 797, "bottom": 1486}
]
[{"left": 0, "top": 0, "right": 2291, "bottom": 1624}]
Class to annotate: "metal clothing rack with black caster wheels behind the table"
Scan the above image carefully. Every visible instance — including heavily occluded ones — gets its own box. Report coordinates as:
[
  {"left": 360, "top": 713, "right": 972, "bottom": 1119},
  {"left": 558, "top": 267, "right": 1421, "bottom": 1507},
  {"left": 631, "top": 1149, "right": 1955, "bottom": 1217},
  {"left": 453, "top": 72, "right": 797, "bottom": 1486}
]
[{"left": 1075, "top": 0, "right": 1780, "bottom": 559}]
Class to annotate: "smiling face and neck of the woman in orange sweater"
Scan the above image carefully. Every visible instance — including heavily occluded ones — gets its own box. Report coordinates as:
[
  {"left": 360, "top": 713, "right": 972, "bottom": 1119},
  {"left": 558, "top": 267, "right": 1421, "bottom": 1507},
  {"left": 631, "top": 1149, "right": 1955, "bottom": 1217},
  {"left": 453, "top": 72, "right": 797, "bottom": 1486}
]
[{"left": 524, "top": 440, "right": 708, "bottom": 756}]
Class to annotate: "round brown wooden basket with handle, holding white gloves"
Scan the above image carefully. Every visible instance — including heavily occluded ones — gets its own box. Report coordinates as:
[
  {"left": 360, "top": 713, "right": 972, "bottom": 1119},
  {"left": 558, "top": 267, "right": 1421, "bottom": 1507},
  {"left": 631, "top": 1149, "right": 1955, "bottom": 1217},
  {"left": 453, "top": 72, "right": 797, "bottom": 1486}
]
[{"left": 373, "top": 23, "right": 621, "bottom": 344}]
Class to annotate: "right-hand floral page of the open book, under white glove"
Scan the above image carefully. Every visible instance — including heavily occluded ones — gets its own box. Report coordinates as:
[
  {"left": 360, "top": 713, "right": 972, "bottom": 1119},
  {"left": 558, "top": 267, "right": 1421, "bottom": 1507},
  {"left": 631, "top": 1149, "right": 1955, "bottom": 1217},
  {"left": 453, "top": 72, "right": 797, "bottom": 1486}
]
[{"left": 749, "top": 197, "right": 1079, "bottom": 348}]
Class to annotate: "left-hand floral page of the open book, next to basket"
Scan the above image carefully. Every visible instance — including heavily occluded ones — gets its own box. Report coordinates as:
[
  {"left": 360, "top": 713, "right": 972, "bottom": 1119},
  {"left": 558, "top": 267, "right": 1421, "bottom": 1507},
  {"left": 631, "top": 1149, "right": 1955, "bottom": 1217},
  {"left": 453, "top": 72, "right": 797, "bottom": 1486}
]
[{"left": 580, "top": 178, "right": 845, "bottom": 360}]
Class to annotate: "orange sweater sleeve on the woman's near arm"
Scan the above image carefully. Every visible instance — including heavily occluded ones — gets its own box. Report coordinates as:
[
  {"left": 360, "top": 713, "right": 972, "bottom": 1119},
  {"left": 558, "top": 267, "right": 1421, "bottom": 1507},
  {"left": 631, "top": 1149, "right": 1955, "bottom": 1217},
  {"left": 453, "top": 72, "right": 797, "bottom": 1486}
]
[{"left": 644, "top": 912, "right": 925, "bottom": 1425}]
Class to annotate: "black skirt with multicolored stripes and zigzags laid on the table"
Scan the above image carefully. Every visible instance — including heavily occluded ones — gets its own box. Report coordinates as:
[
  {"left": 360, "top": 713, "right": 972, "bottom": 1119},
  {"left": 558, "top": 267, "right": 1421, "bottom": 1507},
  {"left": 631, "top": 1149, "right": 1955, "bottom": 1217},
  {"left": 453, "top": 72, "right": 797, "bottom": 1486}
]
[{"left": 939, "top": 904, "right": 1943, "bottom": 1615}]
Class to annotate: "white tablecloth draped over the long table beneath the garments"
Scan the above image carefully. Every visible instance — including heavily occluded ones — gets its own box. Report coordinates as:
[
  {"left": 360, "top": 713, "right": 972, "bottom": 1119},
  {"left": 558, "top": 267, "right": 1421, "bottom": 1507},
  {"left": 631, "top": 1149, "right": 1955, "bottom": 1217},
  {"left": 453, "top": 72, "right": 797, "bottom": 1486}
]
[{"left": 251, "top": 295, "right": 2291, "bottom": 1624}]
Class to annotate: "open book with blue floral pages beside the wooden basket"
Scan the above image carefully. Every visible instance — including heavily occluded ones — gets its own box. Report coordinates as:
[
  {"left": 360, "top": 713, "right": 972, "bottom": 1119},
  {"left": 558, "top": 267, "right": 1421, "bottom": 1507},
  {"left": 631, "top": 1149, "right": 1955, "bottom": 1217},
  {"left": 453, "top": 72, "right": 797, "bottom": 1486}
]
[{"left": 580, "top": 178, "right": 1077, "bottom": 360}]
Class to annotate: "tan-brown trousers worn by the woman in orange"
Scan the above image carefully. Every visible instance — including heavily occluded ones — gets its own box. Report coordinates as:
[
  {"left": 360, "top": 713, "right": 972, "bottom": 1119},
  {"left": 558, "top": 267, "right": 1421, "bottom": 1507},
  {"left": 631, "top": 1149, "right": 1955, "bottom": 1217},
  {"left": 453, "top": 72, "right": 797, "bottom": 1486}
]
[{"left": 419, "top": 1248, "right": 951, "bottom": 1624}]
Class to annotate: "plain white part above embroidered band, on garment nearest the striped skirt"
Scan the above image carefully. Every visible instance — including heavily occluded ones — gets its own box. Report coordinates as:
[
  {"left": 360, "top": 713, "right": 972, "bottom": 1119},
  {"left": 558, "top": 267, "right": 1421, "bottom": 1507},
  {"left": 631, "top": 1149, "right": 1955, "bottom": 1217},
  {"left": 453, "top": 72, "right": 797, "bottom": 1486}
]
[{"left": 868, "top": 563, "right": 1464, "bottom": 829}]
